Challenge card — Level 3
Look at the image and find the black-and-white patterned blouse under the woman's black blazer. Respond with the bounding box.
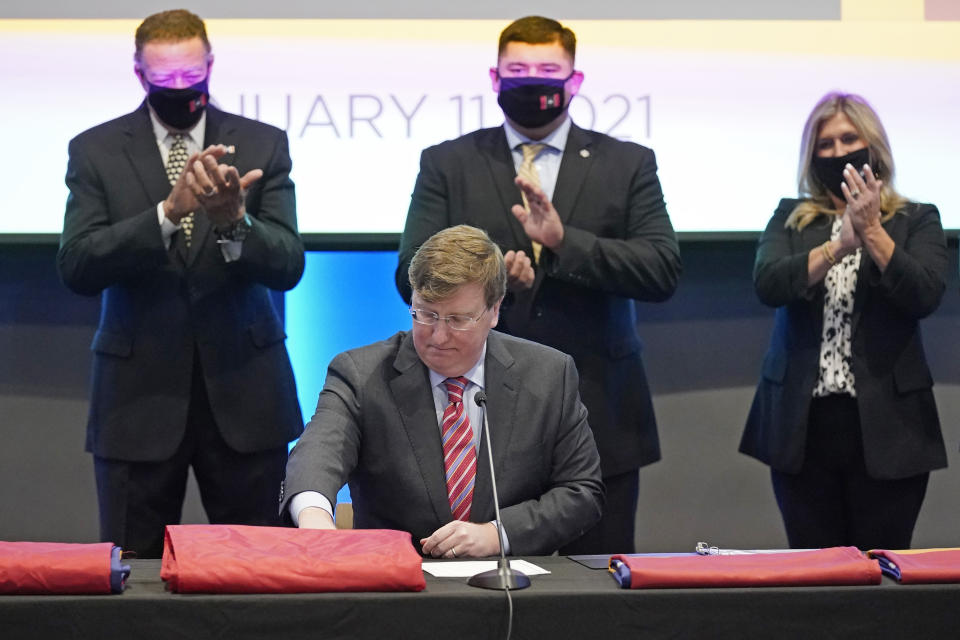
[813,216,861,398]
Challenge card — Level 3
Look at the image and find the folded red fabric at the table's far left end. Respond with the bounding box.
[0,542,113,594]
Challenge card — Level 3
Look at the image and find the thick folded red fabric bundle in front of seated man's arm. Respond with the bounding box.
[160,525,427,593]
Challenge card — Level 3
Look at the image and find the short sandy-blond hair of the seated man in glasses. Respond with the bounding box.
[407,224,507,308]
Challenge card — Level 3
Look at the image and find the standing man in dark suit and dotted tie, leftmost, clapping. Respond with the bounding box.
[57,10,303,557]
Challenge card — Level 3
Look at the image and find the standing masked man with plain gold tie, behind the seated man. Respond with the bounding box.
[396,16,680,554]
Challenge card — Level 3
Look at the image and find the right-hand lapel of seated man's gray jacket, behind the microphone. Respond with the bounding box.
[470,331,520,521]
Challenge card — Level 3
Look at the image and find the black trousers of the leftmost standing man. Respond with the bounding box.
[94,358,287,558]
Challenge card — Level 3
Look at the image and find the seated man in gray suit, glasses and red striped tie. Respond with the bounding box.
[280,225,603,558]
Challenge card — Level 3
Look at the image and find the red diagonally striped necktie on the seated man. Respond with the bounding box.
[440,377,477,521]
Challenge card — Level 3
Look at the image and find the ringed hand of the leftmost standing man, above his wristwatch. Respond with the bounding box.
[184,145,263,229]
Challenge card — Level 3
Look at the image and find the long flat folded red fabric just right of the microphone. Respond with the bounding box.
[613,547,880,589]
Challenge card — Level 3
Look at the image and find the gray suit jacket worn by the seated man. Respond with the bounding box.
[280,331,603,555]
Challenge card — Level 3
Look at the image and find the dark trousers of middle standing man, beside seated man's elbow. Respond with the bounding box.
[560,469,640,556]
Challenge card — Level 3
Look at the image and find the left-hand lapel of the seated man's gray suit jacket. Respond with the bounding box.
[390,333,453,522]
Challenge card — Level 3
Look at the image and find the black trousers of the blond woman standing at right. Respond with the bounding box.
[771,395,930,550]
